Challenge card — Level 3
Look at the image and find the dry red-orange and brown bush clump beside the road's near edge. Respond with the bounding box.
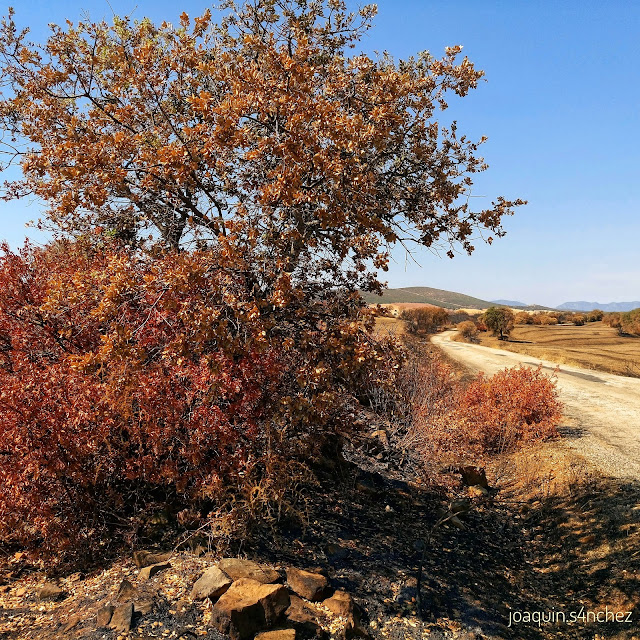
[396,348,562,473]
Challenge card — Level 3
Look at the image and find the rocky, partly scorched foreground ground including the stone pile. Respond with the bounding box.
[0,429,640,640]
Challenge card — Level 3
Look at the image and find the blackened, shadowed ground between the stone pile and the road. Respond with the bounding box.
[250,440,640,640]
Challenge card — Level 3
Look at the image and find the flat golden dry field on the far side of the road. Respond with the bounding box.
[480,322,640,377]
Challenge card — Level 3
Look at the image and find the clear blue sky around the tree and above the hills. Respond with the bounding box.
[0,0,640,305]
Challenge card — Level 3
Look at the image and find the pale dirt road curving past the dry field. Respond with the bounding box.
[432,331,640,480]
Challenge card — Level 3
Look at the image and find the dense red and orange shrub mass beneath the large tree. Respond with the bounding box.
[0,243,381,551]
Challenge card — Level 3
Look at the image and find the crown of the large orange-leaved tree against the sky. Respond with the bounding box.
[0,0,521,290]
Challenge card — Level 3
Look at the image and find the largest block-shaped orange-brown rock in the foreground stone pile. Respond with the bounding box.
[211,578,290,640]
